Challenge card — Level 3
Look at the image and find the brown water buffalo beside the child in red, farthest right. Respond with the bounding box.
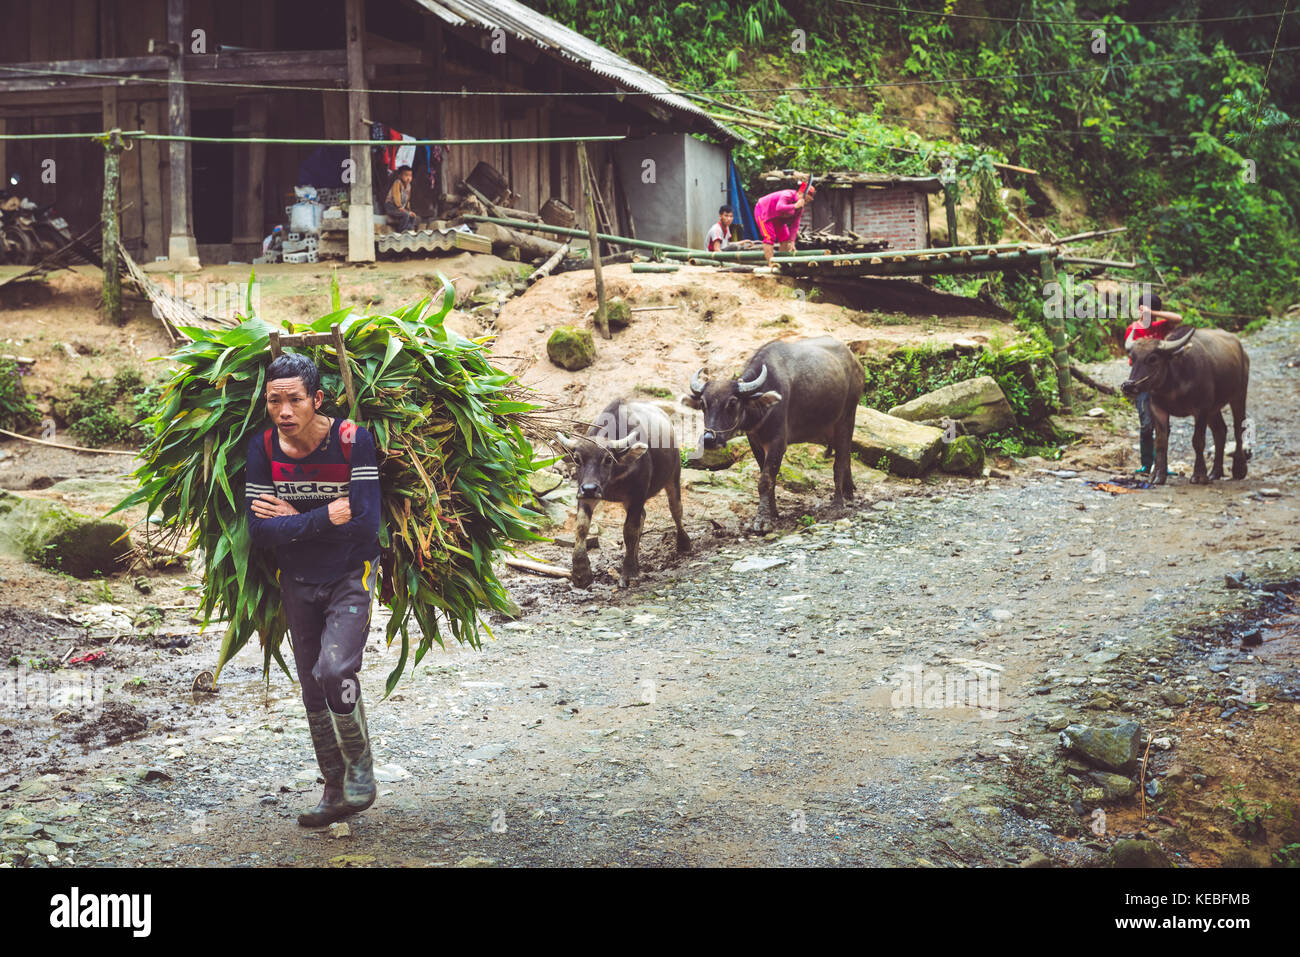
[1122,329,1251,485]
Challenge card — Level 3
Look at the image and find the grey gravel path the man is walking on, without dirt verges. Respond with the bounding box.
[0,322,1300,866]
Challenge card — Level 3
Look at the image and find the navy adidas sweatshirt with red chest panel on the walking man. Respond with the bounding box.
[244,419,380,584]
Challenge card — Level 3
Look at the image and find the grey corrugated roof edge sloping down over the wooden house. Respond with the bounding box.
[415,0,745,140]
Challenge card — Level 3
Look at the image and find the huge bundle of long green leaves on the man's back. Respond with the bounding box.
[114,280,545,693]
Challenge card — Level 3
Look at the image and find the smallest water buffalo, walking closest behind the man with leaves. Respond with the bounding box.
[559,399,690,588]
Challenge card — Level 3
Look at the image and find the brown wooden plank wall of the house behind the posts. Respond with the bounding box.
[0,0,691,250]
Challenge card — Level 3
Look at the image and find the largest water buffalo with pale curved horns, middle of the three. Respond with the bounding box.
[681,335,866,532]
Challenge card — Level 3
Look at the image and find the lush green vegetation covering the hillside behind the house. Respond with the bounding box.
[536,0,1300,358]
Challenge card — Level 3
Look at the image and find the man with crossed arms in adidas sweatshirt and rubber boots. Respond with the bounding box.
[244,352,380,827]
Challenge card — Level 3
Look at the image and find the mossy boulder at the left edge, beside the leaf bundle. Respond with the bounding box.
[0,492,131,579]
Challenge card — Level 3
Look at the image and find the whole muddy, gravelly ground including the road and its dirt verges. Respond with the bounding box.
[0,286,1300,866]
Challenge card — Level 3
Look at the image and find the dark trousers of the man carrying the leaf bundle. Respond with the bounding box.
[280,555,380,714]
